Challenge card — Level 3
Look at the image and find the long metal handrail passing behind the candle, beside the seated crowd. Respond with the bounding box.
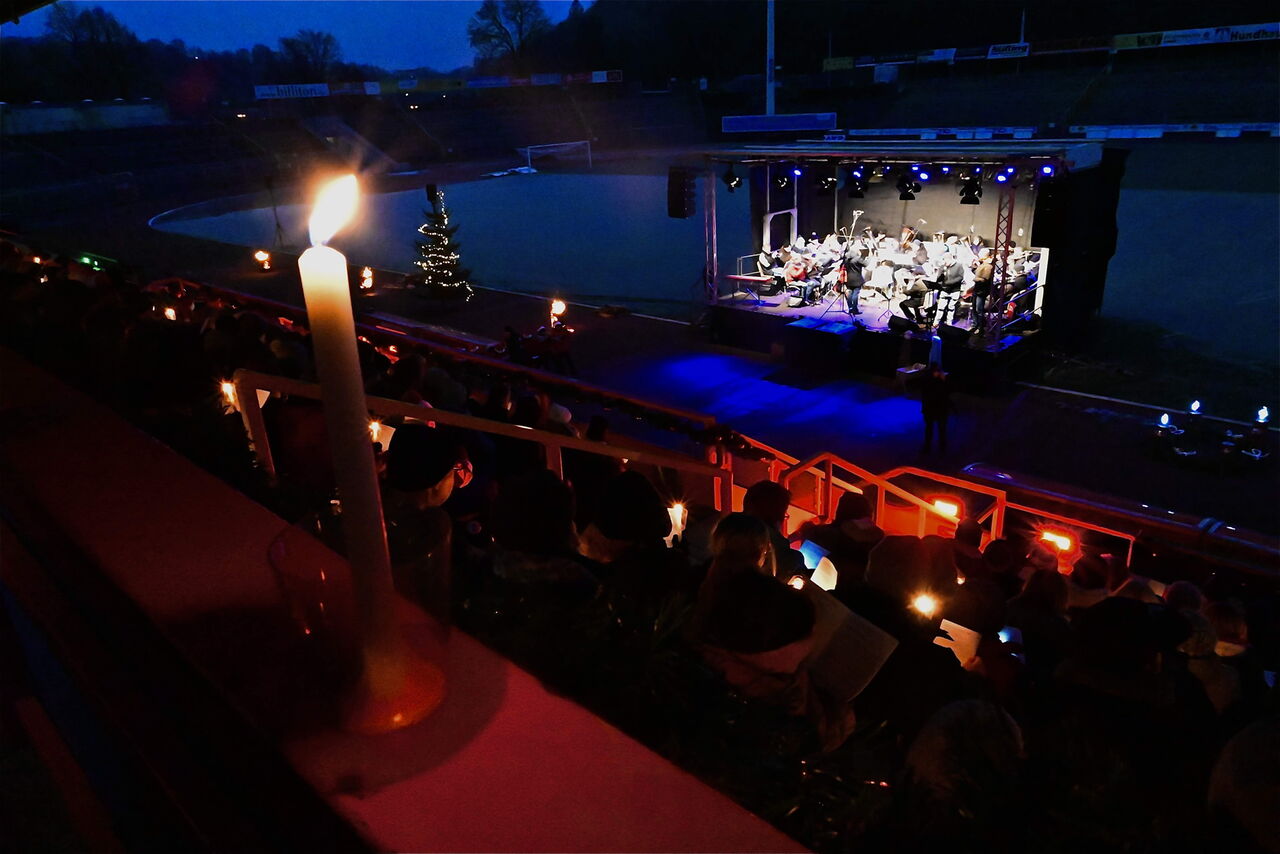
[232,369,733,510]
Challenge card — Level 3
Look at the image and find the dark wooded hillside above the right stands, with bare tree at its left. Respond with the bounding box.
[471,0,1275,83]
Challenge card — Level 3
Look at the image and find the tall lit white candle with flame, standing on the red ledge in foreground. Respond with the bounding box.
[298,175,444,732]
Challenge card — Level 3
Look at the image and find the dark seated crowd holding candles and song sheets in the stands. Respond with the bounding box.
[0,242,1280,851]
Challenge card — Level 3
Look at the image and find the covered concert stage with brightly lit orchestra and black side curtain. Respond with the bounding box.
[686,140,1123,388]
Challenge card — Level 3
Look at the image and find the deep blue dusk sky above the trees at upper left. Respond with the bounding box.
[0,0,590,70]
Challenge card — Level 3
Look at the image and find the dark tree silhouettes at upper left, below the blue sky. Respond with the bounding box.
[0,3,387,110]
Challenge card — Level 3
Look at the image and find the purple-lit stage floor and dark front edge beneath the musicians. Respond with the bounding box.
[710,288,1039,392]
